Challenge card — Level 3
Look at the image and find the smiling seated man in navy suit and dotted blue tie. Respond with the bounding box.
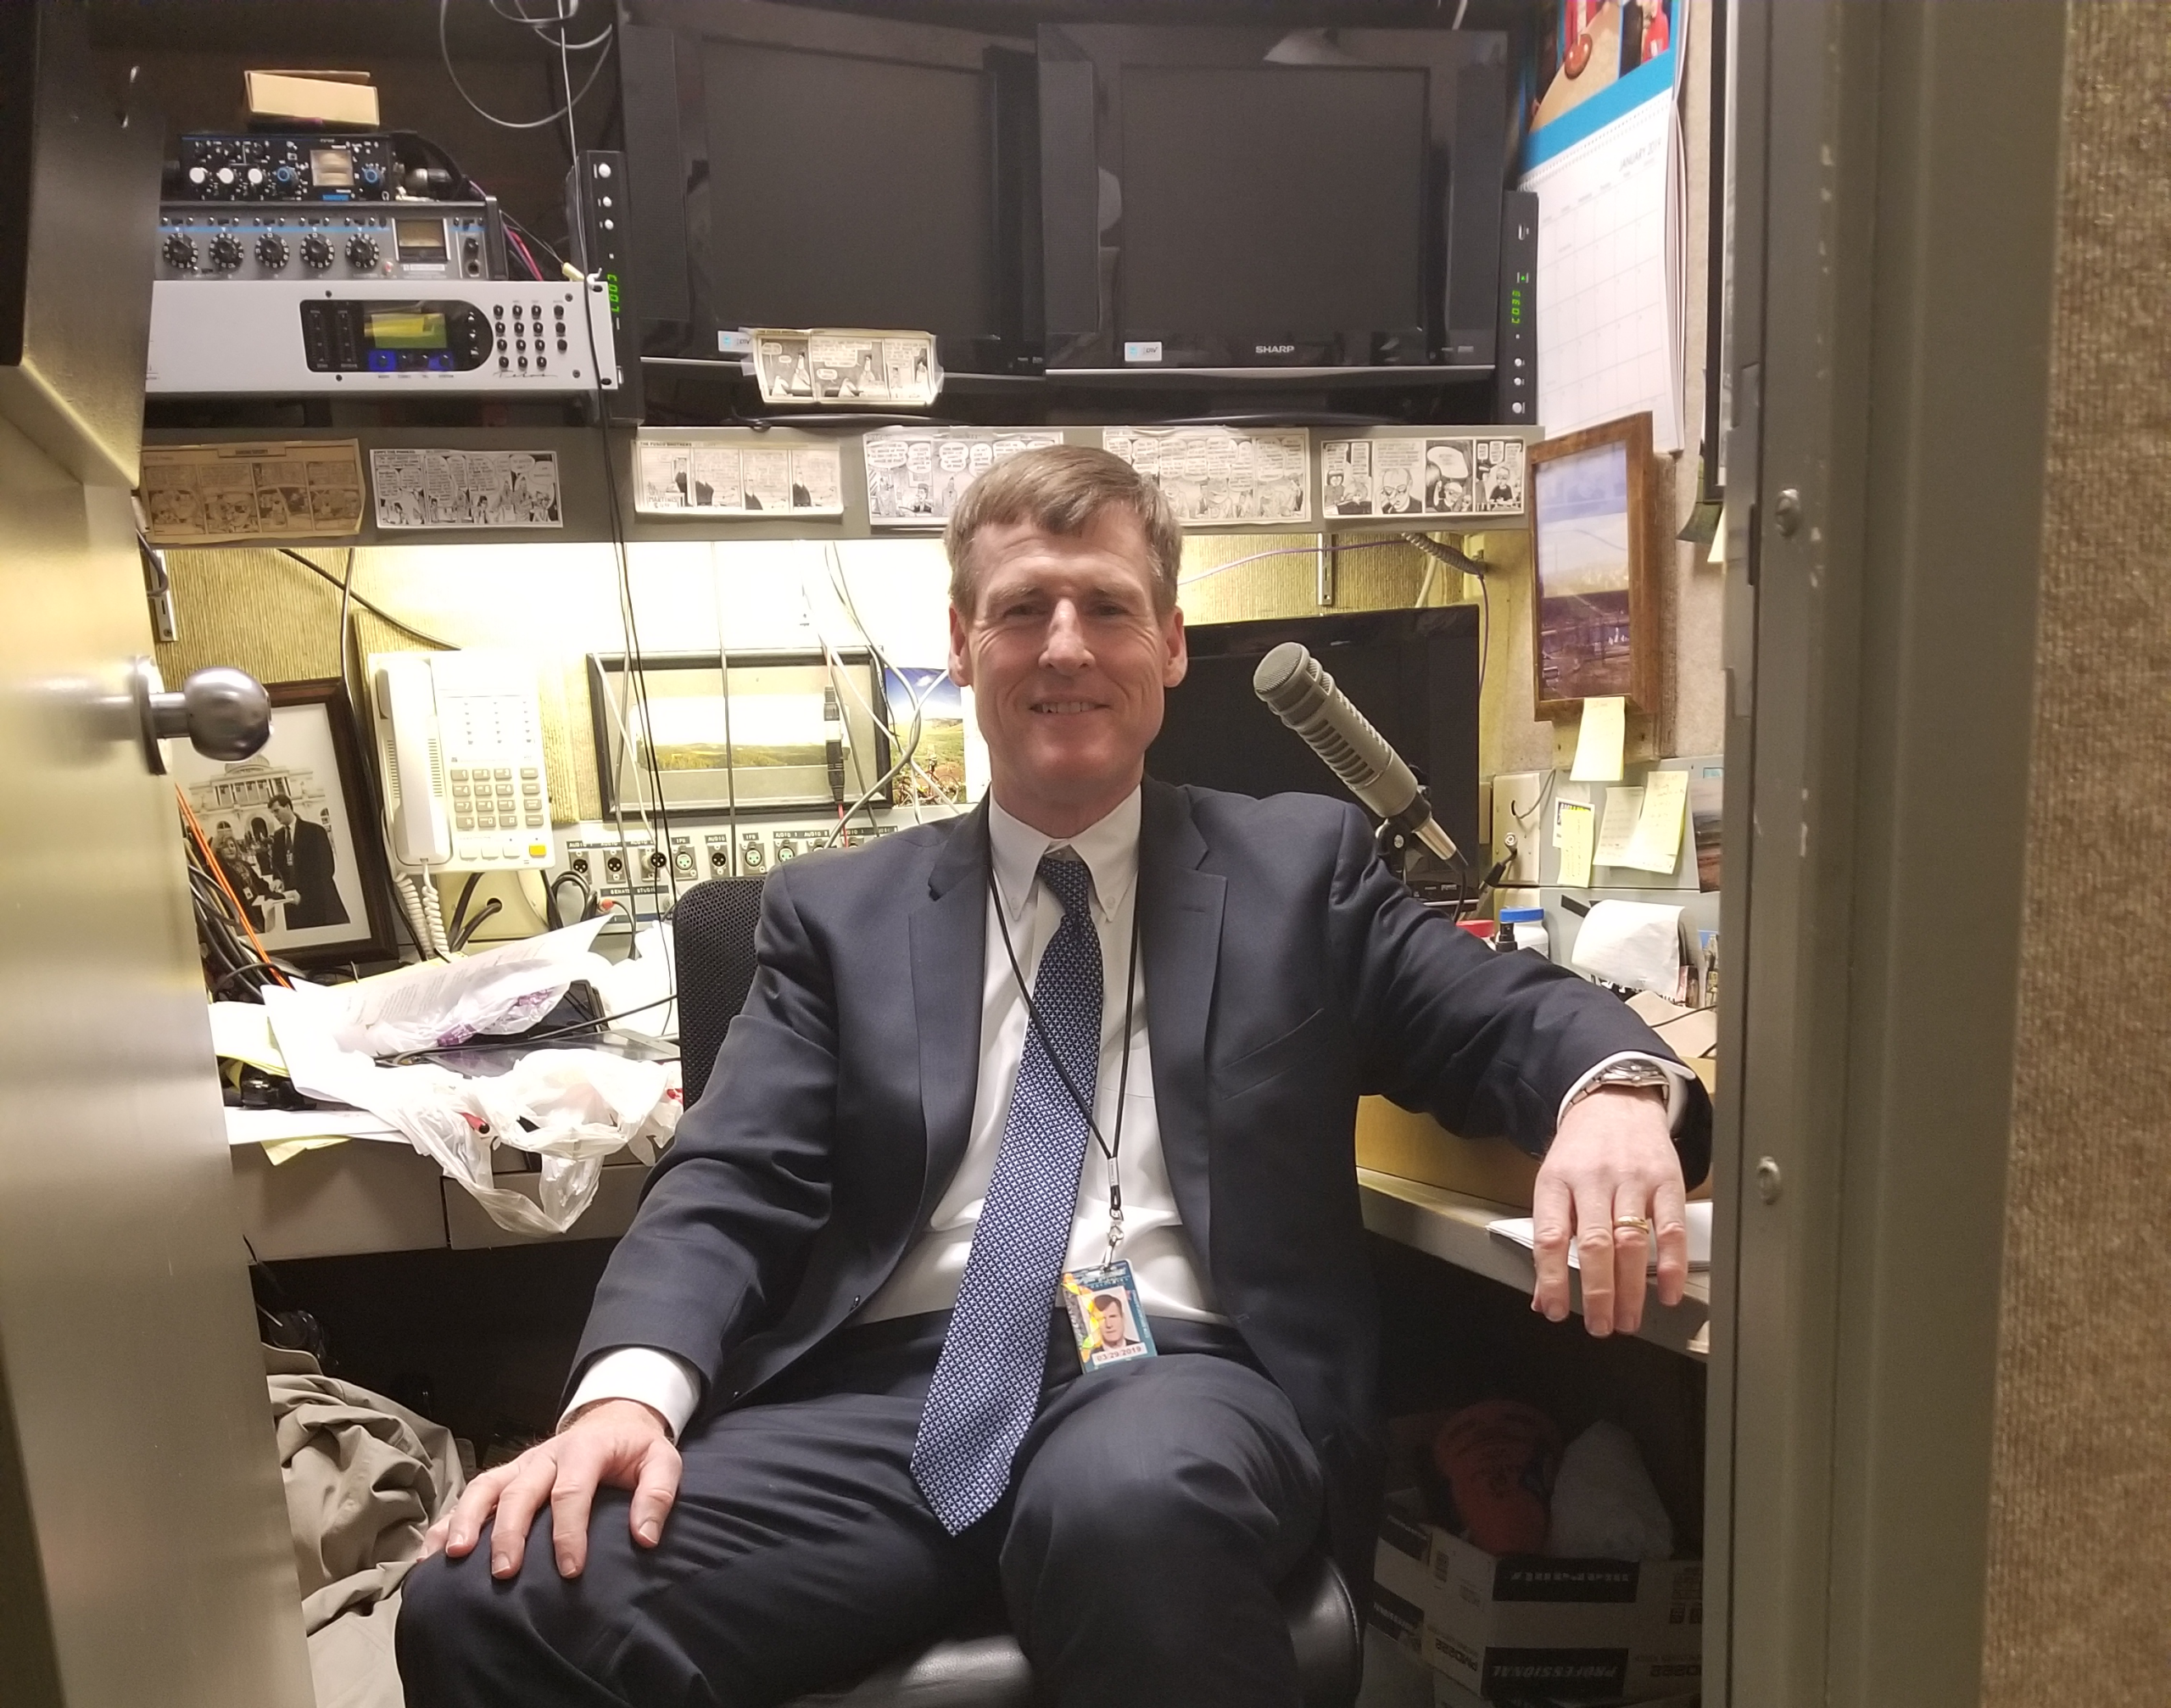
[397,447,1709,1708]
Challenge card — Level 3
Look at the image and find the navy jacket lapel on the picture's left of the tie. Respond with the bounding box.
[912,805,988,1228]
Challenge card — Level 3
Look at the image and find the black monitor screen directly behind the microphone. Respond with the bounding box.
[1147,606,1481,863]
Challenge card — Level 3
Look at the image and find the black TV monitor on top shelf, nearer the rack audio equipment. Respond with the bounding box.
[619,0,1040,373]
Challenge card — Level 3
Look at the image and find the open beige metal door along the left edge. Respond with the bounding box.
[0,7,310,1708]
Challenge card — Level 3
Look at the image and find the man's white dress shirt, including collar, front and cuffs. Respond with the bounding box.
[560,790,1689,1437]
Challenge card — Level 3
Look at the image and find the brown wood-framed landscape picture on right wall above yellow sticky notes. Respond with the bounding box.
[1531,412,1660,718]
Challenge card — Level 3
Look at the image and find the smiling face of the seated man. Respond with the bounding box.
[951,510,1186,835]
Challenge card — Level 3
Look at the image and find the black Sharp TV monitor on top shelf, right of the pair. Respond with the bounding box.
[1040,24,1509,380]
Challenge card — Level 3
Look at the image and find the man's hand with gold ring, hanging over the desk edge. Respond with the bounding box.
[1531,1086,1689,1335]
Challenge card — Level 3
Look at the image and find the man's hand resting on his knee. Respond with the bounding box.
[421,1400,679,1577]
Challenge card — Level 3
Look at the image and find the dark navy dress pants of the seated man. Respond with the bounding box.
[397,1313,1320,1708]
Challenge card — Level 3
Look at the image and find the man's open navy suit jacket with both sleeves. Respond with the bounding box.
[575,779,1711,1582]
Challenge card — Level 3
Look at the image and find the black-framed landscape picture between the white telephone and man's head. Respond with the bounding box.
[589,651,895,816]
